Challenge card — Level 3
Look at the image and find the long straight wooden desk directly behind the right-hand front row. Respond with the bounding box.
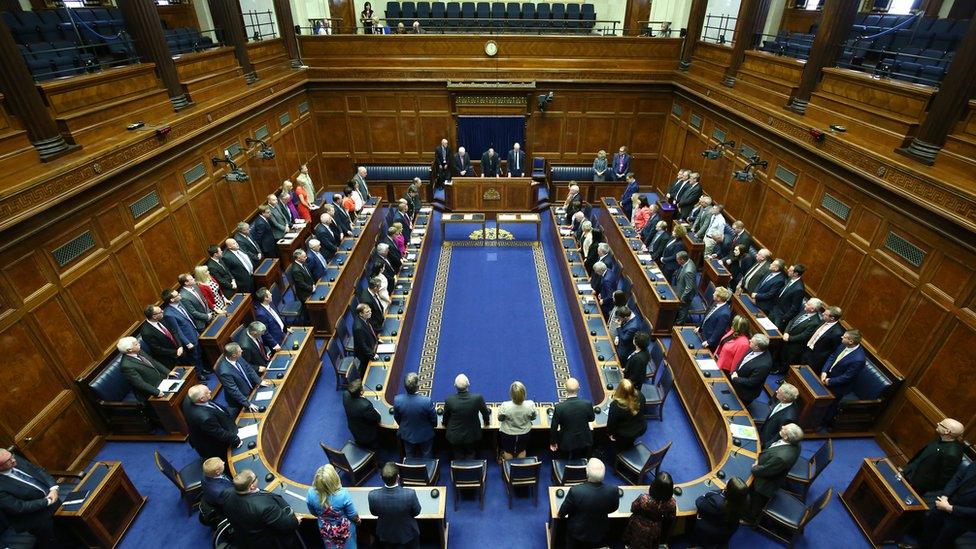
[599,198,681,337]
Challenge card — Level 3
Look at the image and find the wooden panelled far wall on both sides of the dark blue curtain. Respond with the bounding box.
[309,83,671,185]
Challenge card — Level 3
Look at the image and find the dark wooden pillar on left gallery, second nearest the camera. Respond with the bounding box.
[119,0,193,110]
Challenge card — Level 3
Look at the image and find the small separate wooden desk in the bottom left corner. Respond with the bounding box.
[54,461,146,547]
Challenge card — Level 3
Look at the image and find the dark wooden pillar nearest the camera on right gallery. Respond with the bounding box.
[897,19,976,165]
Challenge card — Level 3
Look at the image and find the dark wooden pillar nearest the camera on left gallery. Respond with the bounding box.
[0,16,78,162]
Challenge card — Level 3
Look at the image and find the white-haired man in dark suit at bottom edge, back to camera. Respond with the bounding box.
[559,458,620,549]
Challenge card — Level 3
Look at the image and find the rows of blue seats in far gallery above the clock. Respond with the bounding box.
[386,2,596,29]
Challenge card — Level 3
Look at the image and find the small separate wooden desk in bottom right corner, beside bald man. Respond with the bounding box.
[840,458,928,547]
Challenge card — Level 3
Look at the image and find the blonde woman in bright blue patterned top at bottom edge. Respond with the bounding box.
[305,464,360,549]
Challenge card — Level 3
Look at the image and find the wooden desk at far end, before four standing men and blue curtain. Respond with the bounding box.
[444,177,535,213]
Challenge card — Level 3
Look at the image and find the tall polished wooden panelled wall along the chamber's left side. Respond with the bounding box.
[0,91,318,469]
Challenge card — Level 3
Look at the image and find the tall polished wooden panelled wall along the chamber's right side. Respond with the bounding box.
[655,95,976,456]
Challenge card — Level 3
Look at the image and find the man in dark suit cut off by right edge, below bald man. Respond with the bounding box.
[920,461,976,549]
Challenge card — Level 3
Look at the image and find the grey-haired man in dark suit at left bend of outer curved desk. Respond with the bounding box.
[182,385,243,459]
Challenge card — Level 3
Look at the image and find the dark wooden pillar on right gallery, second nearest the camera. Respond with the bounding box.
[786,0,857,114]
